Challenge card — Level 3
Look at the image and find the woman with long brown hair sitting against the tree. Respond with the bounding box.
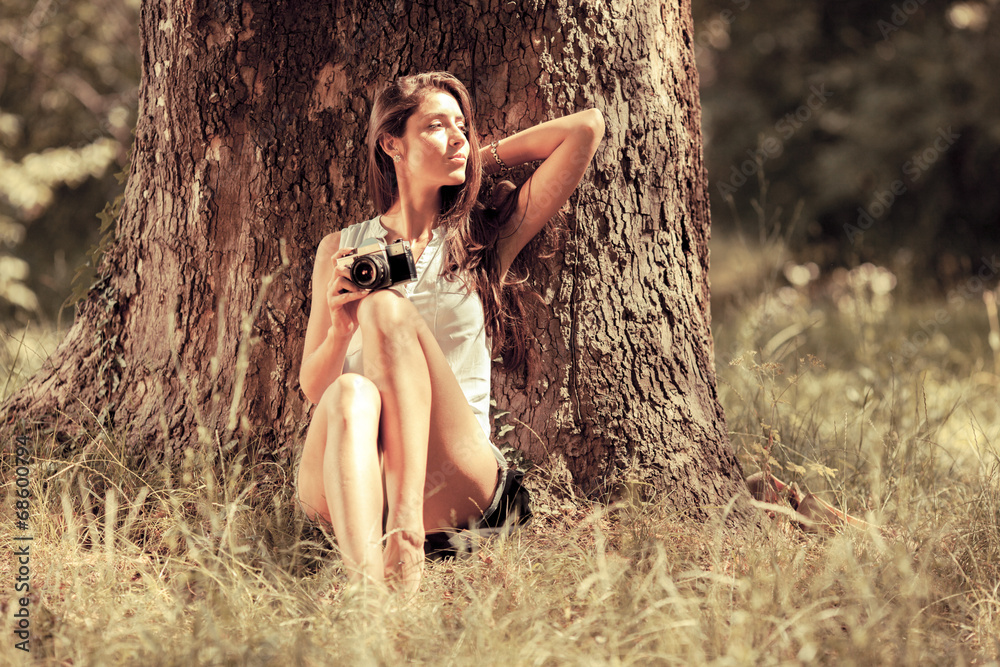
[298,72,604,592]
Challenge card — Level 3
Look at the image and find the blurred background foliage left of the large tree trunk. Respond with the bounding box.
[0,0,140,326]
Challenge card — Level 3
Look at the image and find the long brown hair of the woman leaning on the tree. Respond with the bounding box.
[368,72,561,381]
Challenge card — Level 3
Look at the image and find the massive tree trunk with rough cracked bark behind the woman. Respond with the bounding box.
[6,0,742,509]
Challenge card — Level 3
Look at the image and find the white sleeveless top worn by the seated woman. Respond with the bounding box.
[340,216,503,454]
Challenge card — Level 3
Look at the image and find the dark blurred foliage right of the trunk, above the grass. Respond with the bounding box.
[694,0,1000,287]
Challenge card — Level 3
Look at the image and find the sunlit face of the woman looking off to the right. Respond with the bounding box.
[390,89,469,186]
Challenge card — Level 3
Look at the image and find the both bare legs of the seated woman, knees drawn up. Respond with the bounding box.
[298,291,497,591]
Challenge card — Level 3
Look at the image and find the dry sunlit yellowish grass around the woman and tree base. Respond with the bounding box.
[0,238,1000,665]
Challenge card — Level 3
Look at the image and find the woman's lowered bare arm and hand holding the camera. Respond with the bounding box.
[299,232,368,403]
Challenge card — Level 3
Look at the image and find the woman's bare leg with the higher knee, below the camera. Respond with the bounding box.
[358,290,497,591]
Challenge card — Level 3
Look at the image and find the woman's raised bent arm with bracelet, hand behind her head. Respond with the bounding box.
[480,109,604,275]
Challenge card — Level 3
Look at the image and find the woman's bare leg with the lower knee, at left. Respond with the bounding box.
[299,373,383,584]
